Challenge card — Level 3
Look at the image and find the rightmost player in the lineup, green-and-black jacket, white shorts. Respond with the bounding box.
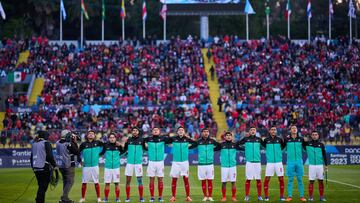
[306,131,327,202]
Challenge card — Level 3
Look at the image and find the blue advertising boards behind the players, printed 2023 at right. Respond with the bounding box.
[0,145,360,168]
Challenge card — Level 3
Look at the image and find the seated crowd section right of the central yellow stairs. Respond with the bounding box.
[209,37,360,144]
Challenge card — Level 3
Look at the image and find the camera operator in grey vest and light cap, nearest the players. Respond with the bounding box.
[56,130,80,203]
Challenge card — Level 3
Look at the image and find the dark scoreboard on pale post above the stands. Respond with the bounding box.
[167,0,245,39]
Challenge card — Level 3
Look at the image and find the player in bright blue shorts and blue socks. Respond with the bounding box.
[284,125,306,202]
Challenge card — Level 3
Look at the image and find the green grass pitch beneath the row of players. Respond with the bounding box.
[0,166,360,203]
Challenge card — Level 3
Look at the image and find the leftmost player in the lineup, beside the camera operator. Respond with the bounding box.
[80,130,103,202]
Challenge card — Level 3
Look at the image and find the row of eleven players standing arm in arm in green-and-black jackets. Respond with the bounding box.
[75,126,327,202]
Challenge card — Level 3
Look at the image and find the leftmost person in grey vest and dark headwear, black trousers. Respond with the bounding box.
[30,131,56,203]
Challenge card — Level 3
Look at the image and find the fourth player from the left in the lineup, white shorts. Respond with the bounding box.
[144,127,170,202]
